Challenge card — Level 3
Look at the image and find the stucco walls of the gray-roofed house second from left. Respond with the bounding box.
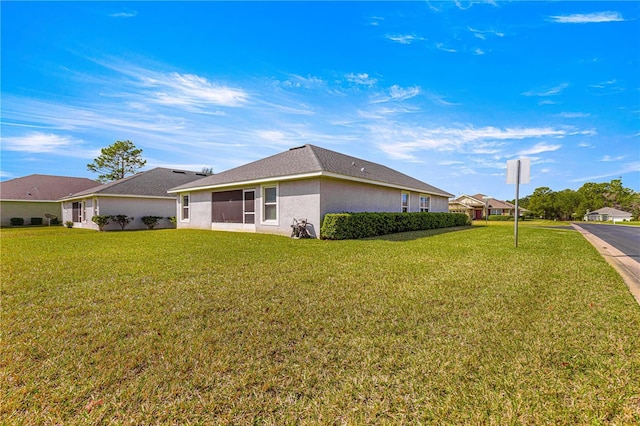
[62,197,176,231]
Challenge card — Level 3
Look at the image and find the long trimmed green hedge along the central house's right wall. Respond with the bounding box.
[320,213,469,240]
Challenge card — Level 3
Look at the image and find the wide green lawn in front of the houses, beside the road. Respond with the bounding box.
[0,222,640,424]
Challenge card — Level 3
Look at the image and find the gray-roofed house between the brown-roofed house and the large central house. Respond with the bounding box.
[60,167,208,230]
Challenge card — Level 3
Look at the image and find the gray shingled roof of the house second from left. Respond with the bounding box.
[60,167,208,199]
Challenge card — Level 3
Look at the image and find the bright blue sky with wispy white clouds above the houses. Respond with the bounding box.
[0,1,640,199]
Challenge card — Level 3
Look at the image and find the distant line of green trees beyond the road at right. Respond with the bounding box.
[510,179,640,220]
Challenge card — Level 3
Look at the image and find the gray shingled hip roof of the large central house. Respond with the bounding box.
[171,145,453,197]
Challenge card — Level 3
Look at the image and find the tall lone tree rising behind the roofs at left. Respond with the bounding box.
[87,140,147,183]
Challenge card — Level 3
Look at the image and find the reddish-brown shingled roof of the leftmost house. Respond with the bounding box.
[0,174,99,201]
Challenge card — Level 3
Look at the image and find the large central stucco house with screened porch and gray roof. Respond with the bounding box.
[169,145,452,237]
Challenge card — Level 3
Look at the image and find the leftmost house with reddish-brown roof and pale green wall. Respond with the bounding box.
[0,174,99,226]
